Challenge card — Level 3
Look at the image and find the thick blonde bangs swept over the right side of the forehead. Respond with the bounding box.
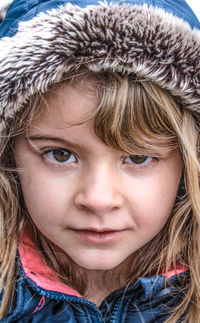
[94,72,182,154]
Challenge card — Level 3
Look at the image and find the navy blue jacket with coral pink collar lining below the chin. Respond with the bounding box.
[0,237,189,323]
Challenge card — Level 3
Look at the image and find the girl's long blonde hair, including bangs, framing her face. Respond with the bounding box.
[0,68,200,323]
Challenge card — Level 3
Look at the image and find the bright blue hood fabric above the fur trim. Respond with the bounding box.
[0,0,200,38]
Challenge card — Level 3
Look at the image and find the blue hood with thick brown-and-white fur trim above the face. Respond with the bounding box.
[0,0,200,129]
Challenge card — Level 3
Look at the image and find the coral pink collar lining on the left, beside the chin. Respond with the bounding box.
[18,235,81,297]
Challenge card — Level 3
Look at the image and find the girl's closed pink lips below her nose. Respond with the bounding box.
[73,228,126,244]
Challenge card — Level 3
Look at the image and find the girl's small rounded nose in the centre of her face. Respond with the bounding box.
[75,166,123,215]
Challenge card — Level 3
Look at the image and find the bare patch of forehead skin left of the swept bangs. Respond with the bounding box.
[32,79,99,127]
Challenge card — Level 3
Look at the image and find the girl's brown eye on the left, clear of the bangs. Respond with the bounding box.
[45,149,76,163]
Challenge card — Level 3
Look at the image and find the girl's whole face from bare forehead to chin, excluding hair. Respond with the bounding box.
[15,81,182,270]
